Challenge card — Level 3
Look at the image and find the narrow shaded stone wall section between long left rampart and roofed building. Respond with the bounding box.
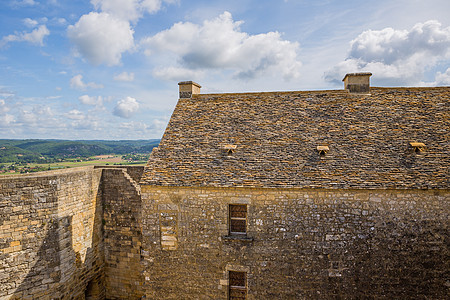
[102,167,143,299]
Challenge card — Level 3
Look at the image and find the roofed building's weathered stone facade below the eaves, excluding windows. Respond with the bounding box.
[141,186,450,299]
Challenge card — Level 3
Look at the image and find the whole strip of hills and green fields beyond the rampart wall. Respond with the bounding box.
[0,139,159,175]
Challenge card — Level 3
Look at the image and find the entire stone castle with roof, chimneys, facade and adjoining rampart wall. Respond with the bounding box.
[0,73,450,300]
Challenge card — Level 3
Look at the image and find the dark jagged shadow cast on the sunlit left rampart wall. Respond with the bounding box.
[8,172,105,300]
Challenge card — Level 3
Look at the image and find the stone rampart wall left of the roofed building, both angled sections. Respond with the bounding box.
[0,167,143,300]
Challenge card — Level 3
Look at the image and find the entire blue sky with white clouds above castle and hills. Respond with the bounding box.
[0,0,450,140]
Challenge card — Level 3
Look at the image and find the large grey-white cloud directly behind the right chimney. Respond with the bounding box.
[325,21,450,84]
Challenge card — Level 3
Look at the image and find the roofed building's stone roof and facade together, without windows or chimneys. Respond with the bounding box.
[141,83,450,299]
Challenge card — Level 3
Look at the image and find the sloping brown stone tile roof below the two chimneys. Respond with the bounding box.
[141,87,450,189]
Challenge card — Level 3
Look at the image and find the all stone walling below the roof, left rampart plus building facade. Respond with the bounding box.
[0,167,450,300]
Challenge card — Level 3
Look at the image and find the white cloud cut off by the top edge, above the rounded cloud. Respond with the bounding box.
[91,0,161,21]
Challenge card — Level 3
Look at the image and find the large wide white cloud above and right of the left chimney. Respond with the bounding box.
[141,12,301,79]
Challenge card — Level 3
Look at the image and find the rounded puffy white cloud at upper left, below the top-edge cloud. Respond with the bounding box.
[67,12,134,66]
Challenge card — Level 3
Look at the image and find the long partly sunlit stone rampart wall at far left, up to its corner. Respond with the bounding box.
[0,167,104,299]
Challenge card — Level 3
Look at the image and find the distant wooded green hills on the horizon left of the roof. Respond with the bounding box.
[0,139,160,163]
